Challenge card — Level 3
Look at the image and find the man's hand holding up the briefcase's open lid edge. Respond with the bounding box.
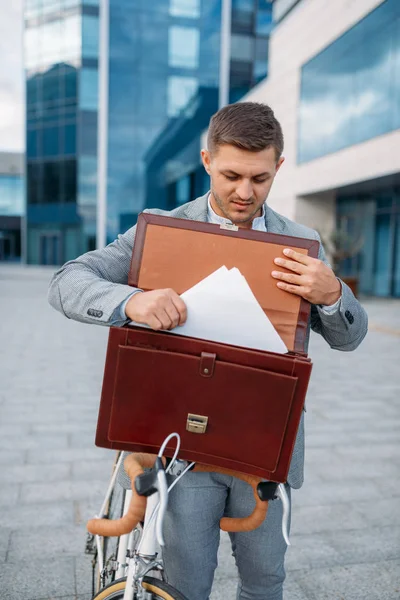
[272,248,342,306]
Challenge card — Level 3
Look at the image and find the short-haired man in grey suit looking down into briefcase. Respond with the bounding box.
[49,102,367,600]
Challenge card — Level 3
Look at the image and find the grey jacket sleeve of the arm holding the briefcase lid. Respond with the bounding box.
[311,234,368,351]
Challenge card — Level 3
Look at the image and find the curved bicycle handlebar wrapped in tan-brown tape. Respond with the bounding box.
[87,453,268,537]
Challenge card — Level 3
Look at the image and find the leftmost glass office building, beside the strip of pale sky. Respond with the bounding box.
[25,0,99,264]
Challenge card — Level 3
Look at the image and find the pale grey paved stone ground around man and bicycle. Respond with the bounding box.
[0,265,400,600]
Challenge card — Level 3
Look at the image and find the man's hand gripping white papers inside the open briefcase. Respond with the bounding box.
[125,289,187,330]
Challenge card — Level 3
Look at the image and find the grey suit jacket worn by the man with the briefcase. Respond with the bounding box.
[48,194,367,488]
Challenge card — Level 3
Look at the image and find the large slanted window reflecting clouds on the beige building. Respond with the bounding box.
[298,0,400,163]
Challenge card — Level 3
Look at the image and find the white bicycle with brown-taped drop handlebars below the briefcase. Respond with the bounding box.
[86,433,290,600]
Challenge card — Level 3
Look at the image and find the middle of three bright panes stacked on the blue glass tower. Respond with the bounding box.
[168,25,200,69]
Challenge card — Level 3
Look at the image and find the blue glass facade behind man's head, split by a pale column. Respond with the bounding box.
[104,0,271,241]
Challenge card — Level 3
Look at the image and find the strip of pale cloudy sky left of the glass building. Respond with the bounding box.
[0,0,25,152]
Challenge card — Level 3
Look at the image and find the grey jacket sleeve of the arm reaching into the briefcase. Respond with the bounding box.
[48,226,136,325]
